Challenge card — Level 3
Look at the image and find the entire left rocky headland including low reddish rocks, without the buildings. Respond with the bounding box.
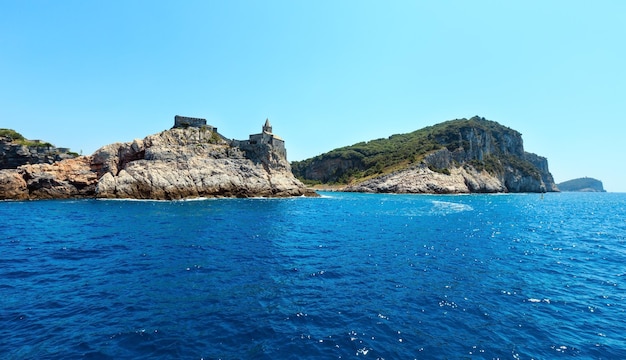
[0,127,316,199]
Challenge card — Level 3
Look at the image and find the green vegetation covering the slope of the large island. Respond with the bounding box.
[291,116,539,184]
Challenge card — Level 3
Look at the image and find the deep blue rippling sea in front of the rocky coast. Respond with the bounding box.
[0,192,626,359]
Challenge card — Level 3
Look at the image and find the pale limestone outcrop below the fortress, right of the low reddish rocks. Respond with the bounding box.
[94,128,314,199]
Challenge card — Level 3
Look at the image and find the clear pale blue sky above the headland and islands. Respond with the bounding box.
[0,0,626,192]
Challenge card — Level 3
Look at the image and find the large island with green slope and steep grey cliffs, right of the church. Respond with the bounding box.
[291,116,559,194]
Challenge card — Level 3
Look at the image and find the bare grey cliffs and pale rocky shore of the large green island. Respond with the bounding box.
[346,127,558,194]
